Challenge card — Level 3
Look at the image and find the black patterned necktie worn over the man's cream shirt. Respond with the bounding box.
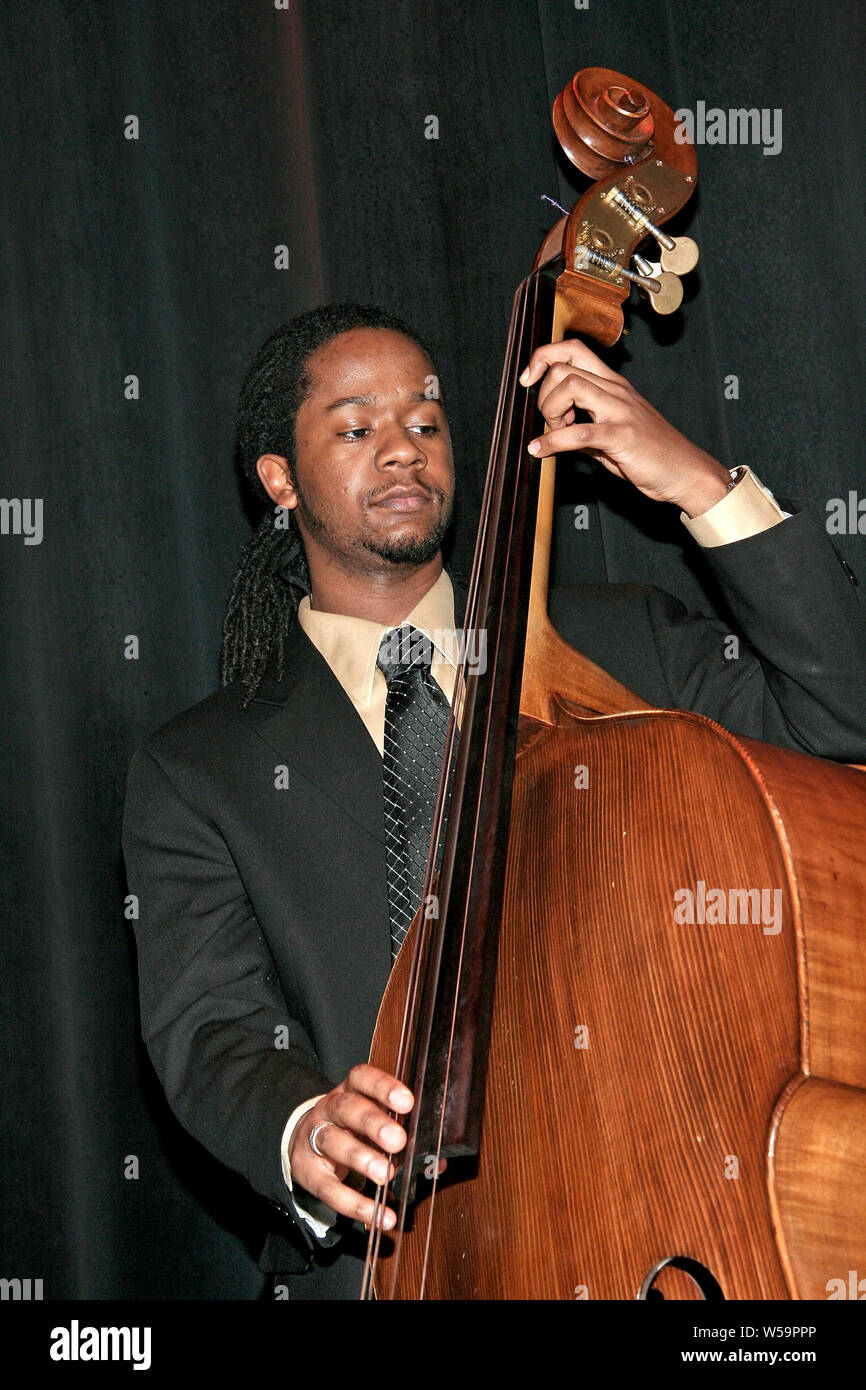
[377,626,453,959]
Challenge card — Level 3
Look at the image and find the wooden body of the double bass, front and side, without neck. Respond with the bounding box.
[371,700,866,1300]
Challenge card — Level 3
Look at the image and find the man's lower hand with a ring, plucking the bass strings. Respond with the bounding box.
[289,1062,414,1230]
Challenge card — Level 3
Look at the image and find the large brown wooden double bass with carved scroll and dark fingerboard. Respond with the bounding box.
[361,68,866,1300]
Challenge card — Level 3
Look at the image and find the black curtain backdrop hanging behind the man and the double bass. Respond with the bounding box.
[0,0,866,1300]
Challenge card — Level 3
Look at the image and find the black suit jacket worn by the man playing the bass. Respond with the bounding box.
[124,510,866,1284]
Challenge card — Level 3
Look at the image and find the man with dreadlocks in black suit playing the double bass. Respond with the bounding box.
[124,304,866,1297]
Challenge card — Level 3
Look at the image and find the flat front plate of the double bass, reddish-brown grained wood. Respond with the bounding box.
[374,710,799,1298]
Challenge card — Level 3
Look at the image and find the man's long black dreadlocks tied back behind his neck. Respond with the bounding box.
[220,303,444,706]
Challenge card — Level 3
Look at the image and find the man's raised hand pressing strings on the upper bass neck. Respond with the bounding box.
[520,338,731,517]
